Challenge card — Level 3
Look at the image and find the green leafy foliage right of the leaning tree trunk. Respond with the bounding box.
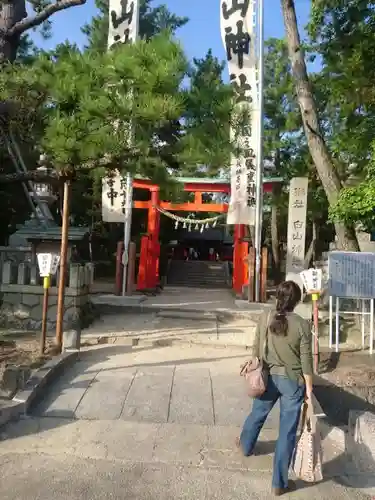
[309,0,375,230]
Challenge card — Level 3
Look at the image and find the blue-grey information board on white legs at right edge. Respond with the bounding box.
[328,251,375,299]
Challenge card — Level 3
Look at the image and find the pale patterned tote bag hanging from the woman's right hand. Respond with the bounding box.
[293,402,323,483]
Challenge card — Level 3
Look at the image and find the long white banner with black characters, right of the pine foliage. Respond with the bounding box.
[220,0,259,225]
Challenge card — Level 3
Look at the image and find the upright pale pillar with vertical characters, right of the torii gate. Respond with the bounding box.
[286,177,309,284]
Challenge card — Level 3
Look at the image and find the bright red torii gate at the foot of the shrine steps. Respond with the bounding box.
[133,177,281,293]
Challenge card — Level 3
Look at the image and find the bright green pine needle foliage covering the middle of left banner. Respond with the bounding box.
[1,36,187,173]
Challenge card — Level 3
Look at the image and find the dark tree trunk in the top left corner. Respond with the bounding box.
[0,0,27,64]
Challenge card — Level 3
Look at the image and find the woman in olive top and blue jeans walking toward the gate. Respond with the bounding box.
[239,281,313,496]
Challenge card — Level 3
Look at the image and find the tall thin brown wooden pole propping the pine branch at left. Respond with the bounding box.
[56,180,71,352]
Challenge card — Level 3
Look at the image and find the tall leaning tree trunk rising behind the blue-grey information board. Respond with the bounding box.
[281,0,359,251]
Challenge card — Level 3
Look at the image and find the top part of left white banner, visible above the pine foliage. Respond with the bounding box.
[108,0,139,49]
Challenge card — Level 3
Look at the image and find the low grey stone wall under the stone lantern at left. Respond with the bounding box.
[0,261,93,330]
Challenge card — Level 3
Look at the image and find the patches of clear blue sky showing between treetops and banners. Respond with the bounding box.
[34,0,310,60]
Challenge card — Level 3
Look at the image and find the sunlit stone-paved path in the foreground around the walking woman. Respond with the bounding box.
[0,344,368,500]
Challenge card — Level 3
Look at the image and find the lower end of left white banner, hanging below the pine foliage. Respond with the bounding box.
[102,173,132,223]
